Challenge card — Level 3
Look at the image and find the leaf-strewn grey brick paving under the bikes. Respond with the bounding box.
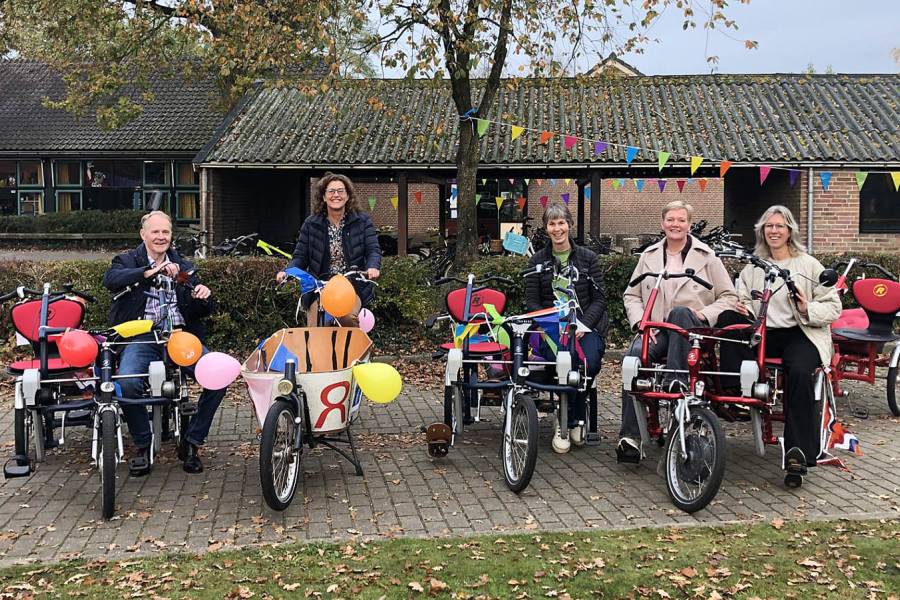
[0,368,900,565]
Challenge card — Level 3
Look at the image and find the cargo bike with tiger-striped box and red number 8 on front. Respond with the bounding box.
[241,268,402,511]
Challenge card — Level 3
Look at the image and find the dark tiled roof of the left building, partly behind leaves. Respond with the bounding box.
[0,60,225,155]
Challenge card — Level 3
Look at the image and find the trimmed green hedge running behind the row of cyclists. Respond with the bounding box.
[0,254,900,356]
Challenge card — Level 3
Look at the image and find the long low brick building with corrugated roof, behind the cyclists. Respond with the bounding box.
[195,75,900,251]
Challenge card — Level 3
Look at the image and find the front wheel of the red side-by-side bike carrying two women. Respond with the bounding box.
[666,407,725,513]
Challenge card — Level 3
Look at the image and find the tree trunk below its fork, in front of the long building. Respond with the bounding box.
[453,121,481,273]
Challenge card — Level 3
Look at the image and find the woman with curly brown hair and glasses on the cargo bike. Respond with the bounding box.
[276,173,381,327]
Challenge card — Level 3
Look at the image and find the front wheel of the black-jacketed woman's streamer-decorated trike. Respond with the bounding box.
[501,394,539,494]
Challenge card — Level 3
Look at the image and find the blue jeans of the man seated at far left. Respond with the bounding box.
[116,335,227,448]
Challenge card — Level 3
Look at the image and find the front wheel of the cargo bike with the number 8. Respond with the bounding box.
[259,400,300,510]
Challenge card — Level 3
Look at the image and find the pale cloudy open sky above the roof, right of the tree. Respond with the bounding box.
[622,0,900,75]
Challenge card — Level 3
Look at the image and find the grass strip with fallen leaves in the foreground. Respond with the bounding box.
[0,519,900,599]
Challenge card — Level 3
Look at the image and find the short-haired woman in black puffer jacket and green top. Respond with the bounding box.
[525,203,609,453]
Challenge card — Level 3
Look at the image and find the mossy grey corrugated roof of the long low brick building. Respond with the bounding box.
[195,75,900,167]
